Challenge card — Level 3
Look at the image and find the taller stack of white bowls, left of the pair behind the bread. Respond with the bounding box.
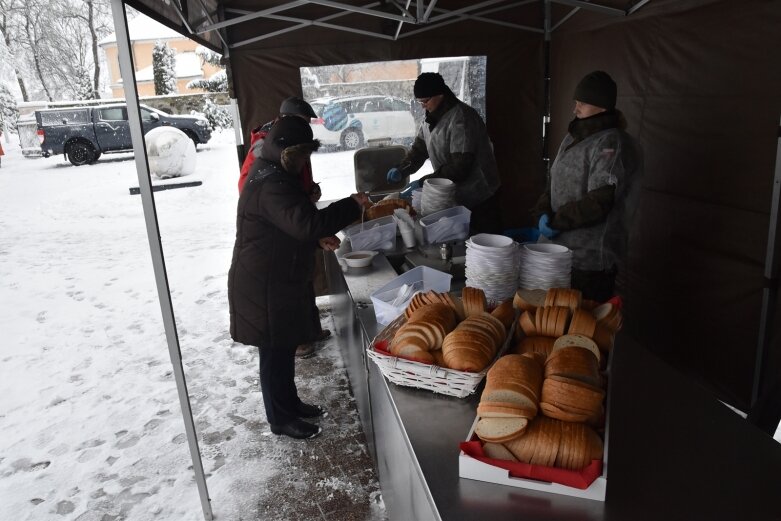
[464,233,520,304]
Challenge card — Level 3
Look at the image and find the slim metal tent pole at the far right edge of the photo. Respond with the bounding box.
[751,121,781,407]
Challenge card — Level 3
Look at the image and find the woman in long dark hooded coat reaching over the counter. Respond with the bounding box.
[228,118,367,438]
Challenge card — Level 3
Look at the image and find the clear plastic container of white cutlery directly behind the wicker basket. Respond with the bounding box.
[371,266,453,326]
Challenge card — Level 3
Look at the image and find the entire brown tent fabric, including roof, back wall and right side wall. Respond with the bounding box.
[126,0,781,409]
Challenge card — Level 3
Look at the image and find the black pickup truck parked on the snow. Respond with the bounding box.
[35,104,211,166]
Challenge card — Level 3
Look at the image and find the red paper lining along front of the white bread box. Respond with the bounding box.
[459,440,602,490]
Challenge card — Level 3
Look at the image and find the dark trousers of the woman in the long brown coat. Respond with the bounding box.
[258,346,301,425]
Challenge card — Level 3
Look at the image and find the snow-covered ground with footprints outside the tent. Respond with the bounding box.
[0,132,388,521]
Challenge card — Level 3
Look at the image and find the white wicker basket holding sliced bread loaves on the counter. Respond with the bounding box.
[366,313,516,398]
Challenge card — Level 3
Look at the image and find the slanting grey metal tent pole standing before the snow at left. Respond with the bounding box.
[111,0,214,521]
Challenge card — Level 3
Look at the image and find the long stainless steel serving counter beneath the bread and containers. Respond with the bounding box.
[327,250,781,521]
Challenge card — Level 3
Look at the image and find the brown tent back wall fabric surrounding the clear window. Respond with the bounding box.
[231,29,544,230]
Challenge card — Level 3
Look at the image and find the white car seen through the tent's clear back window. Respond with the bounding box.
[309,96,417,150]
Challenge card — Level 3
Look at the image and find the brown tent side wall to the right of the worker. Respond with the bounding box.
[551,0,781,408]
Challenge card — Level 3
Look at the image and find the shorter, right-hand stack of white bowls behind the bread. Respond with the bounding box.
[518,242,572,289]
